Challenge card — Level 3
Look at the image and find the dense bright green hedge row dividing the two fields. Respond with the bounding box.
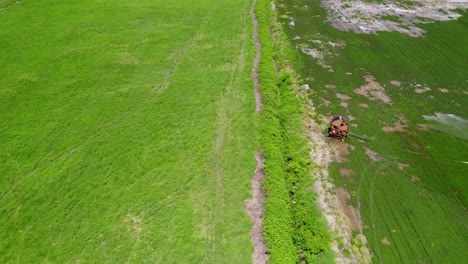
[255,0,332,264]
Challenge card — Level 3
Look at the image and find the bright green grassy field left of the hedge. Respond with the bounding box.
[0,0,258,263]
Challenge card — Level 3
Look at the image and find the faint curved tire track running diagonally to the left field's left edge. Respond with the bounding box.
[0,16,209,201]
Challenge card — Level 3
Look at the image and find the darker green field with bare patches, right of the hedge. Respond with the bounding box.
[276,0,468,263]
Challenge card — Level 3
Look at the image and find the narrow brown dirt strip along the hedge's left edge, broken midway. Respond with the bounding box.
[245,0,268,264]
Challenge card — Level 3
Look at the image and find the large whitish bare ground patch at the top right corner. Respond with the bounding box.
[321,0,468,37]
